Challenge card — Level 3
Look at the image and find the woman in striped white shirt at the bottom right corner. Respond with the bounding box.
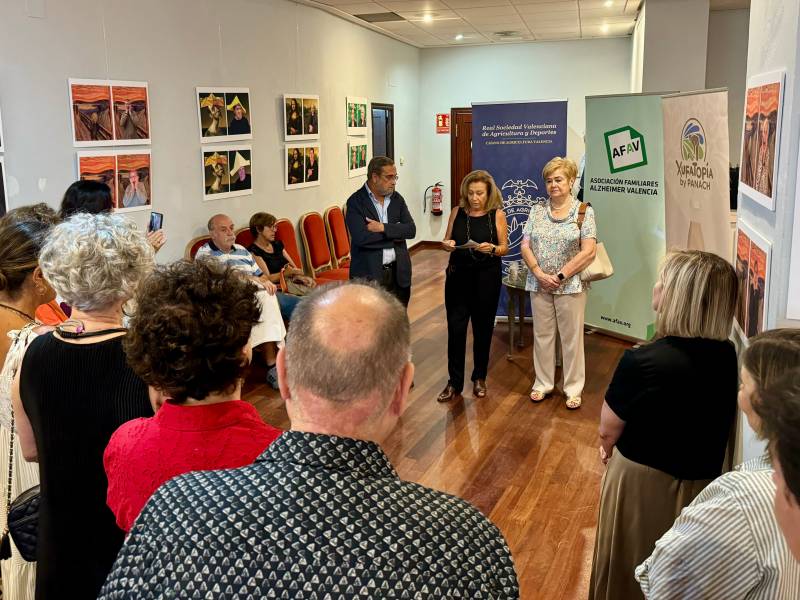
[636,329,800,599]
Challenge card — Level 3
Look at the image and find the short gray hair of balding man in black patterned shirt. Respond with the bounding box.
[285,281,411,403]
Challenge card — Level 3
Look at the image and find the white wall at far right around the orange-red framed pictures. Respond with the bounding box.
[739,0,800,458]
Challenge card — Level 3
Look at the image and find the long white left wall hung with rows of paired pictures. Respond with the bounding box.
[0,0,419,260]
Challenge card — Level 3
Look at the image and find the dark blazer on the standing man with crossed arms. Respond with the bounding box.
[345,186,417,287]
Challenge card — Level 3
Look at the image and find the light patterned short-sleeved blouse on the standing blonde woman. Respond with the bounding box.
[522,199,597,294]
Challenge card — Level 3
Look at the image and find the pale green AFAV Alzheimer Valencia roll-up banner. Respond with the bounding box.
[584,94,665,340]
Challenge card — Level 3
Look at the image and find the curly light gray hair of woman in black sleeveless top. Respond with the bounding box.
[39,213,153,311]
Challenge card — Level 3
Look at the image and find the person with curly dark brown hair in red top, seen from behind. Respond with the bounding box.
[103,260,281,531]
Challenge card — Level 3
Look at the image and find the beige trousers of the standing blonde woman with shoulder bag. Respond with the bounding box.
[531,292,586,398]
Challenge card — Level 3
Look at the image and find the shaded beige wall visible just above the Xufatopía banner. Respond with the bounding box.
[706,9,750,166]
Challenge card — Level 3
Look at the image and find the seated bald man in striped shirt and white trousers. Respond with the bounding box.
[195,214,286,390]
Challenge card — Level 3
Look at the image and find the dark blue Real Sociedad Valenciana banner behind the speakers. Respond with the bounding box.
[472,100,567,316]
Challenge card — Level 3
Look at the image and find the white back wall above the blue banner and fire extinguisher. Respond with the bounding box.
[413,38,631,240]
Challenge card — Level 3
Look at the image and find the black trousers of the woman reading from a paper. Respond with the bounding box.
[444,260,501,392]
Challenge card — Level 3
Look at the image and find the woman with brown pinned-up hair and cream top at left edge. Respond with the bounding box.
[0,204,58,600]
